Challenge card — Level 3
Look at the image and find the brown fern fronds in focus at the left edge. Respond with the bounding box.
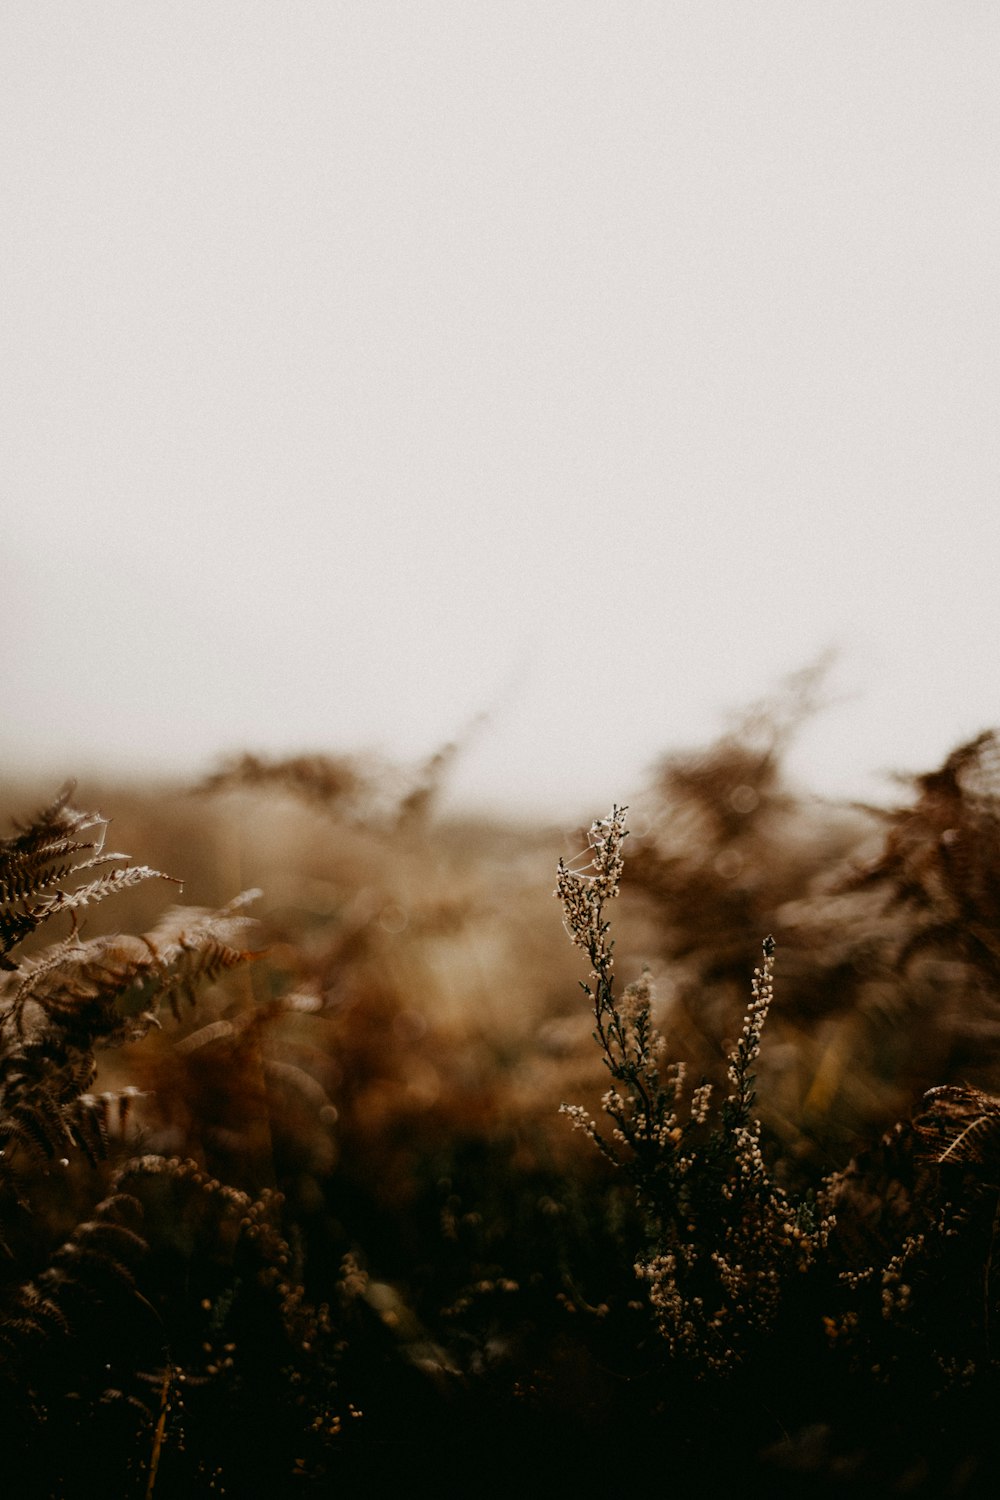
[0,785,258,1199]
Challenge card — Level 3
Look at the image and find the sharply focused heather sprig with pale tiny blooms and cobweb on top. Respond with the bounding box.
[556,807,831,1376]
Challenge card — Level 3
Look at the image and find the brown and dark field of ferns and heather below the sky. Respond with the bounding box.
[0,692,1000,1500]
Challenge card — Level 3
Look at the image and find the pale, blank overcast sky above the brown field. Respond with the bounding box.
[0,0,1000,815]
